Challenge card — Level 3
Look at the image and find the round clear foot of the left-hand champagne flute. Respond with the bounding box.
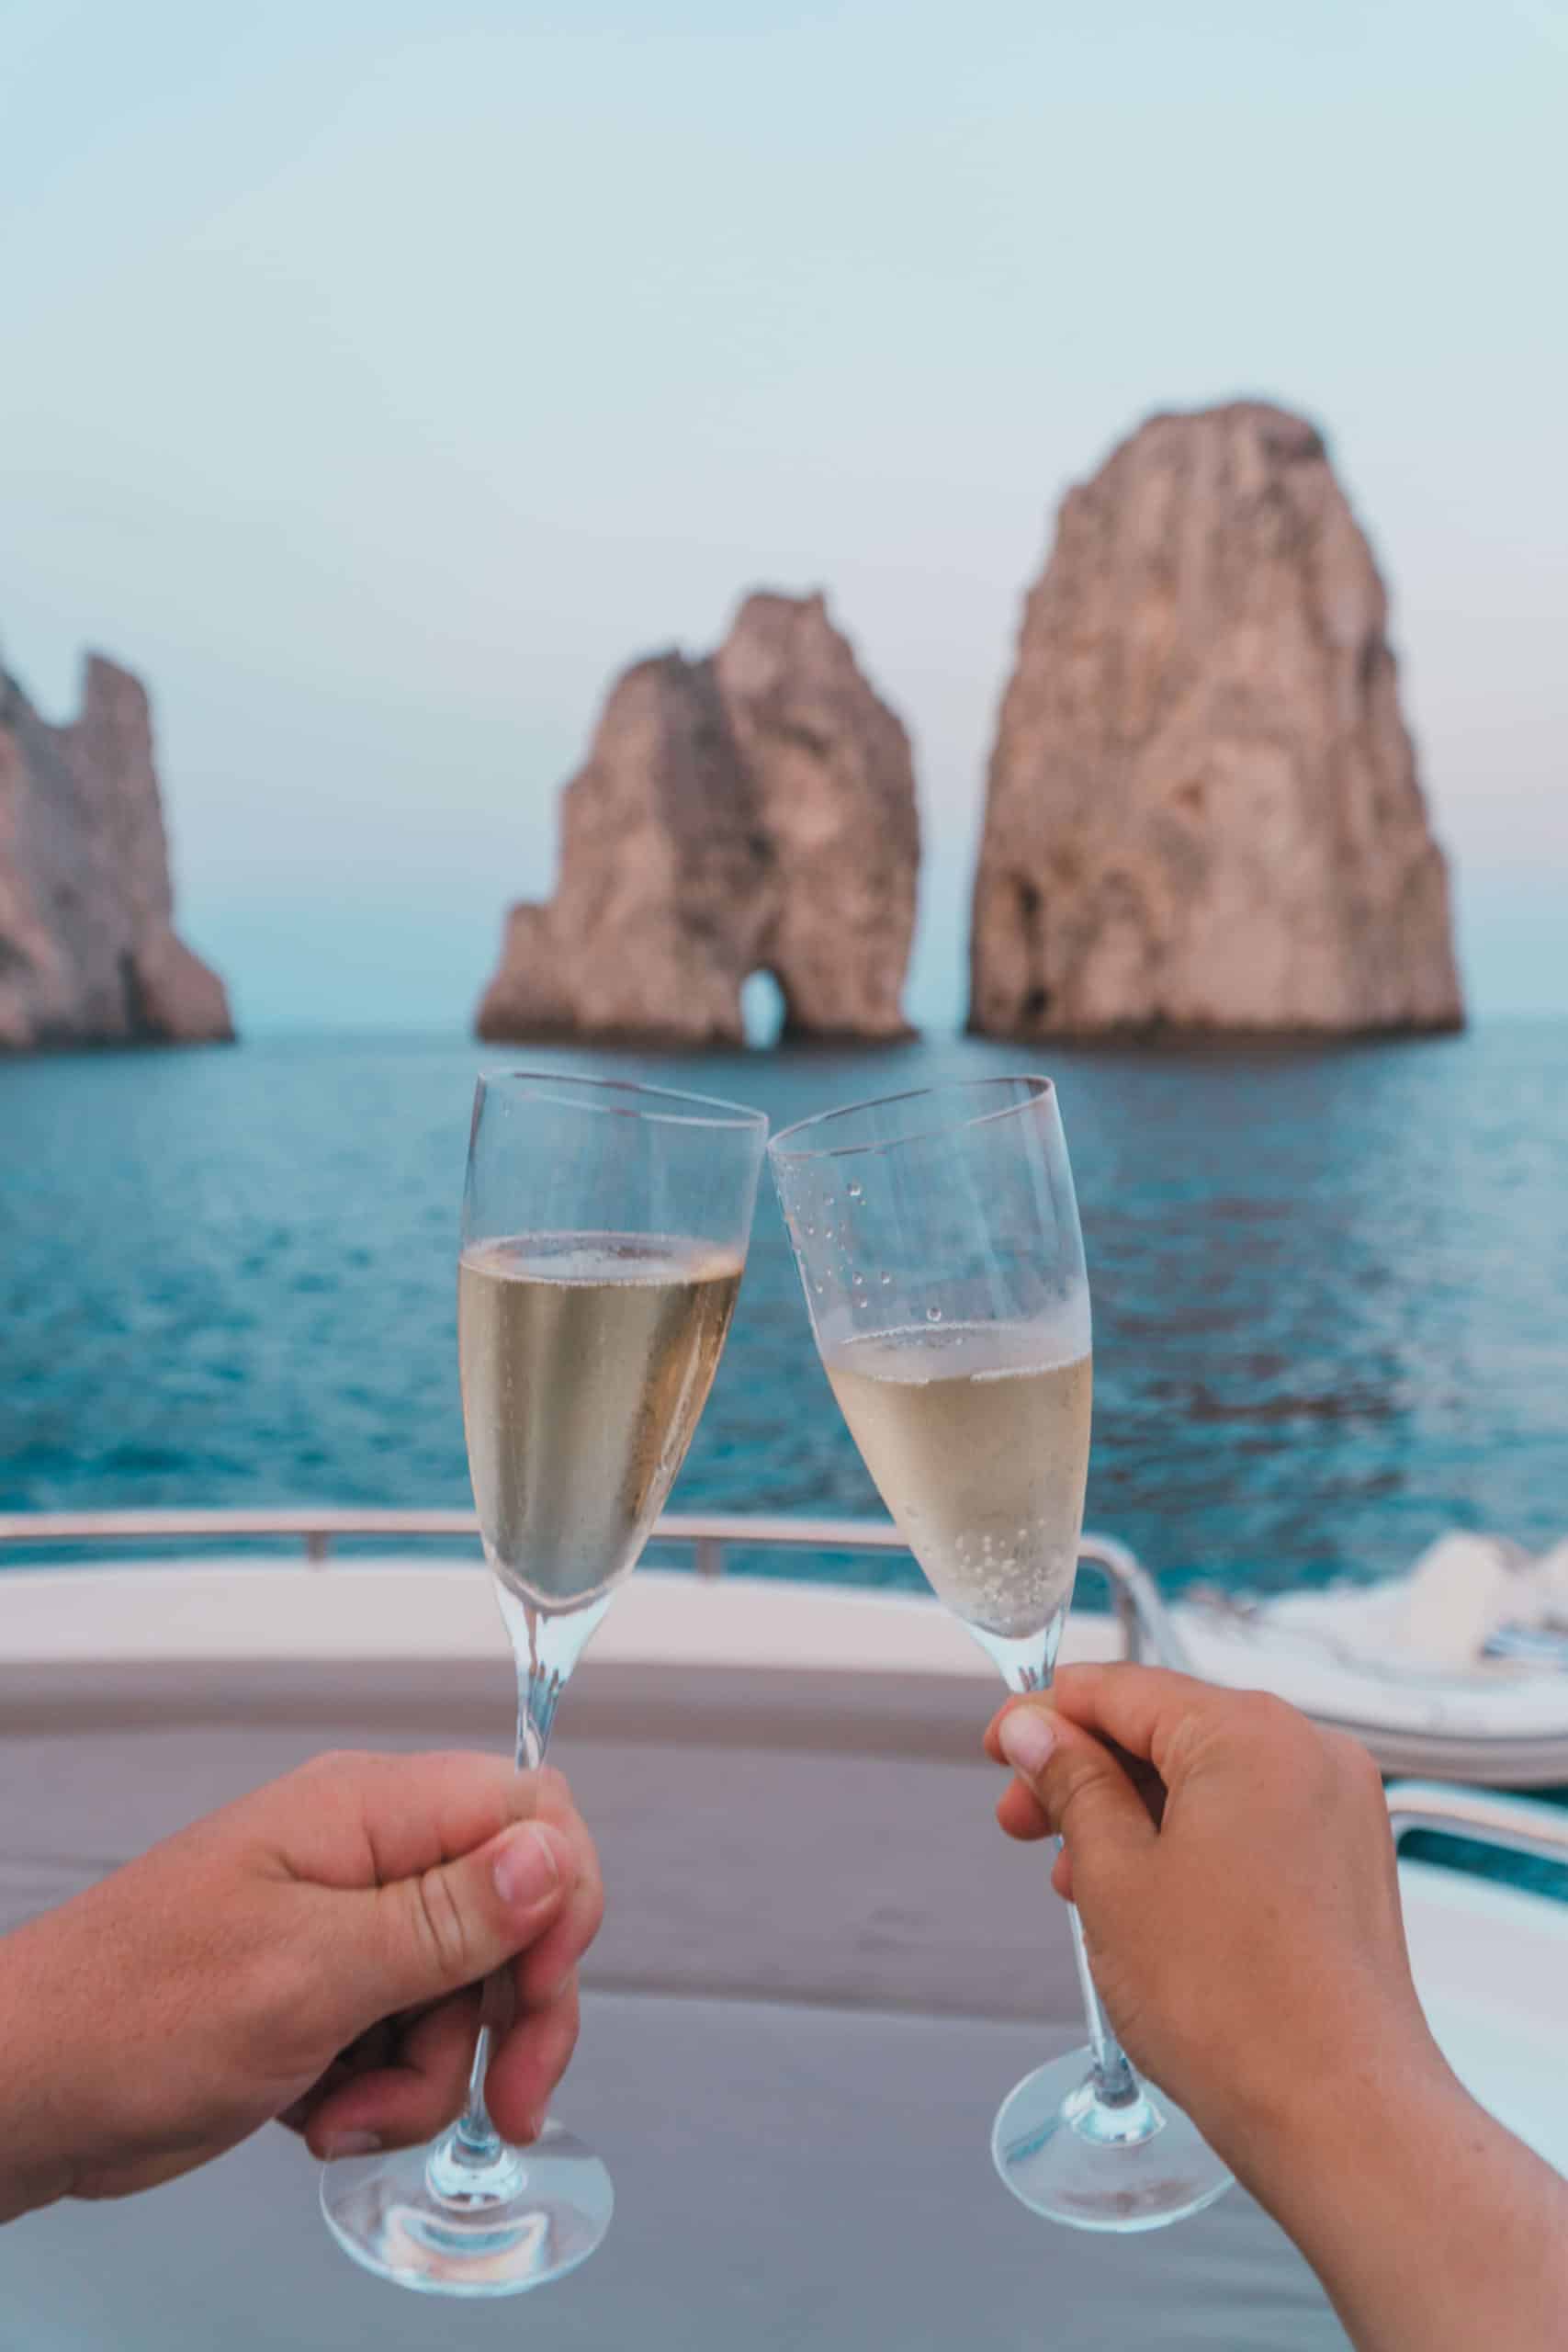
[322,2124,616,2296]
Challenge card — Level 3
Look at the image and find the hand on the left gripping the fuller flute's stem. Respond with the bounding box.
[0,1755,604,2221]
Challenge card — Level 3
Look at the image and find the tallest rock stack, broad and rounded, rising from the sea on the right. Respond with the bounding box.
[968,402,1464,1037]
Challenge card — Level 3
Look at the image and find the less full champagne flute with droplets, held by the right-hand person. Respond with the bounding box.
[769,1077,1229,2230]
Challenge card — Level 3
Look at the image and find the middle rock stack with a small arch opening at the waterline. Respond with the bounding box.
[478,595,919,1046]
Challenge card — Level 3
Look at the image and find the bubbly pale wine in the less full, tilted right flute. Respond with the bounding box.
[825,1317,1093,1639]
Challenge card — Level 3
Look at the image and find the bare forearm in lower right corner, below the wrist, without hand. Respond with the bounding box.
[1248,2067,1568,2352]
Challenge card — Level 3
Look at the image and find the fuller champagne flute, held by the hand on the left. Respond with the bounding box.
[322,1070,766,2296]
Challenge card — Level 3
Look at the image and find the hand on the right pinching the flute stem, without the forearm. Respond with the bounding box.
[987,1665,1453,2192]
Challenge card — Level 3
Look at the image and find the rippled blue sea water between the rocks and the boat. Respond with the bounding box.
[0,1023,1568,1590]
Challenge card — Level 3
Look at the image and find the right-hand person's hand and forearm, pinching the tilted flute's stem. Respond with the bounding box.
[985,1665,1568,2352]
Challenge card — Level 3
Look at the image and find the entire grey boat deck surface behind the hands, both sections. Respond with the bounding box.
[0,1677,1345,2352]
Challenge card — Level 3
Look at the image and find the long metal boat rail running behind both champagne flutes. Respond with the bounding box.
[0,1505,1187,1668]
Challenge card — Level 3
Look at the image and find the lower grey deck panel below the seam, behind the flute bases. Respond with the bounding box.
[0,1995,1345,2352]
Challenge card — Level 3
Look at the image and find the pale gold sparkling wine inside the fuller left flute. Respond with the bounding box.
[458,1232,740,1609]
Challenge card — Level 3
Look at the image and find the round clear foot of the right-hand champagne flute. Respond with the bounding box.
[992,2049,1232,2232]
